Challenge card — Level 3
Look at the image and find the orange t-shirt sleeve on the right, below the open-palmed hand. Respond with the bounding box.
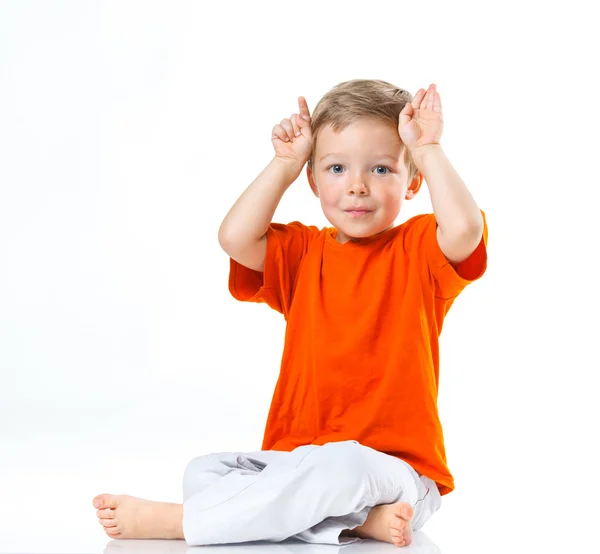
[415,210,488,299]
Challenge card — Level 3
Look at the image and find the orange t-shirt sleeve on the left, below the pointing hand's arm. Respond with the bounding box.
[229,221,319,319]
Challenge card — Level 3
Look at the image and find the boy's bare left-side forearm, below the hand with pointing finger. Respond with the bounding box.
[219,157,302,244]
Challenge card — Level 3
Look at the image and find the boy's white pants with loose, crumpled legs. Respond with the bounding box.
[183,440,441,546]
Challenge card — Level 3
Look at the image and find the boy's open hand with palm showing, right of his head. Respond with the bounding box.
[398,83,444,153]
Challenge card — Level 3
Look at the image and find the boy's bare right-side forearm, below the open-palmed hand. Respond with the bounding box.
[412,145,483,236]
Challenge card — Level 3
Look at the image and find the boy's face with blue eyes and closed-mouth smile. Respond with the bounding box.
[307,119,422,243]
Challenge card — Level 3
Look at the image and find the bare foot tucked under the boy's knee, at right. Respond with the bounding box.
[342,502,414,546]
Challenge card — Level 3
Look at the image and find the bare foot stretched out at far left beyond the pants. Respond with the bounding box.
[94,494,184,539]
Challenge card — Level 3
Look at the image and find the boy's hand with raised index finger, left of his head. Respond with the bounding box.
[271,96,312,168]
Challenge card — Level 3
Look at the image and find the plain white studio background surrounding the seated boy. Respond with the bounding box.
[0,0,600,554]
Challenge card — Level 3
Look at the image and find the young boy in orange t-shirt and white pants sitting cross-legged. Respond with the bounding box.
[94,79,487,546]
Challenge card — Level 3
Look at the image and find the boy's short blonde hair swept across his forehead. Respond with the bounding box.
[308,79,419,182]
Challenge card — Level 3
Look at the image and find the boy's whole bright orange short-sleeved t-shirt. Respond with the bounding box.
[229,211,487,495]
